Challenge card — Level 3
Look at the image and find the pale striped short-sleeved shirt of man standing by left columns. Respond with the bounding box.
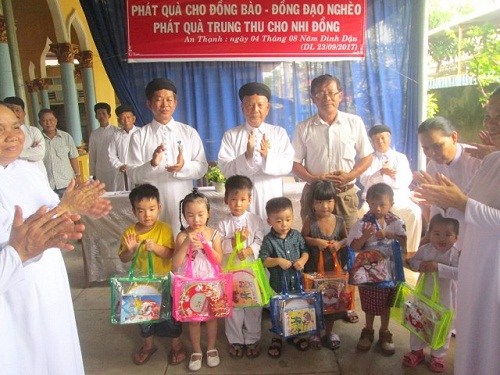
[43,129,79,189]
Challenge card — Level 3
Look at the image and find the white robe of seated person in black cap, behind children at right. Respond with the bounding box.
[359,149,413,202]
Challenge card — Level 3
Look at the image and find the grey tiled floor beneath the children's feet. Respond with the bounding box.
[65,247,454,375]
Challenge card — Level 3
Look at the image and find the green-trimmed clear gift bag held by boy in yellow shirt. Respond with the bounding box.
[110,241,171,324]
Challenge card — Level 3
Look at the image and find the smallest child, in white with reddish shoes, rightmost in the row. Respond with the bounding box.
[403,214,459,372]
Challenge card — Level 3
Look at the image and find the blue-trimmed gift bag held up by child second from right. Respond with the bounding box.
[347,240,405,288]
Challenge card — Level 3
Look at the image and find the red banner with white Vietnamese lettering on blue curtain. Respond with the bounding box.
[127,0,366,62]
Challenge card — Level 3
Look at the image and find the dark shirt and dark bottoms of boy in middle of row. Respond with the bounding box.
[259,228,309,293]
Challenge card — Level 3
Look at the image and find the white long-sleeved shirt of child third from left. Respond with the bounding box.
[218,211,266,266]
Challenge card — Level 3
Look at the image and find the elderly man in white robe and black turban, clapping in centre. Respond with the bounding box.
[218,82,293,222]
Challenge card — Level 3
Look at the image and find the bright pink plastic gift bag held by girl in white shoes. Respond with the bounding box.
[172,235,233,322]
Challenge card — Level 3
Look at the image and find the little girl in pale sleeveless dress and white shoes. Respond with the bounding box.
[173,188,222,371]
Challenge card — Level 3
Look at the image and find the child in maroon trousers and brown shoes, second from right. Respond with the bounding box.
[347,183,406,355]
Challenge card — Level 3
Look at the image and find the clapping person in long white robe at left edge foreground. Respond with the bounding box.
[0,105,111,375]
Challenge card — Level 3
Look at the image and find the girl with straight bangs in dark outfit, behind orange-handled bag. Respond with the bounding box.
[302,180,347,350]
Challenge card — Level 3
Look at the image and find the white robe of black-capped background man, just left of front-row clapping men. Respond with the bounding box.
[108,126,139,191]
